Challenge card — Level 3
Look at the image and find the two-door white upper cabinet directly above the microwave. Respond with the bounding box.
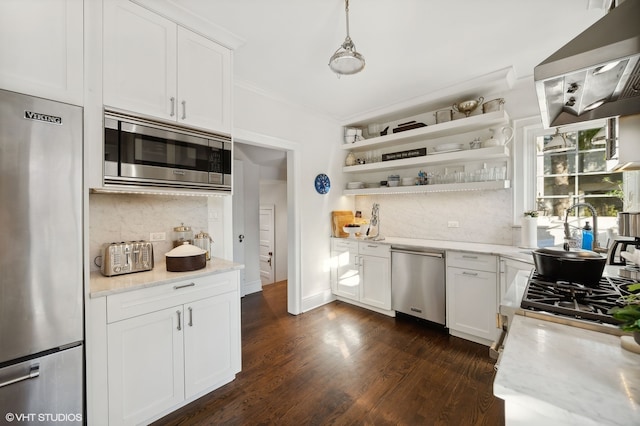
[104,0,231,134]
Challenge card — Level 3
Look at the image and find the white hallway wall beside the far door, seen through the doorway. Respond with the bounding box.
[260,181,289,282]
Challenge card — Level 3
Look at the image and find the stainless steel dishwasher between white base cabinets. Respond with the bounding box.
[391,245,446,325]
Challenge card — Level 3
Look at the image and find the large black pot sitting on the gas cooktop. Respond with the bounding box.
[533,248,607,287]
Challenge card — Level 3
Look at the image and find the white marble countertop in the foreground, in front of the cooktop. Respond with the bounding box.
[493,315,640,425]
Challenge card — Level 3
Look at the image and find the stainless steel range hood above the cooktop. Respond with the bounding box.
[534,0,640,128]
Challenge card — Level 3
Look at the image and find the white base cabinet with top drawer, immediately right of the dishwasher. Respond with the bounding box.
[446,251,499,346]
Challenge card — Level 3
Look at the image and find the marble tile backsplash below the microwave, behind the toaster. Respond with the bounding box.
[89,194,209,271]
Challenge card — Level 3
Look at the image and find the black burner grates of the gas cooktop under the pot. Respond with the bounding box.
[520,270,637,325]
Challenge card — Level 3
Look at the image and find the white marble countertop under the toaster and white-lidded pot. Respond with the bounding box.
[89,257,244,298]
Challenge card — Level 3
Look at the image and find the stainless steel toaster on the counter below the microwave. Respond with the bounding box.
[101,241,153,277]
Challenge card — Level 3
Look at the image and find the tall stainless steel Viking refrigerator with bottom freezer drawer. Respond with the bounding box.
[0,90,84,424]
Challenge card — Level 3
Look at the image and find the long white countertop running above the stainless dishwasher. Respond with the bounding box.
[334,237,533,264]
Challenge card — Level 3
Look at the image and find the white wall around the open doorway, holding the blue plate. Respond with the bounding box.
[234,84,353,311]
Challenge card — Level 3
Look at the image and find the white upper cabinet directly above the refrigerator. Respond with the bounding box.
[0,0,83,105]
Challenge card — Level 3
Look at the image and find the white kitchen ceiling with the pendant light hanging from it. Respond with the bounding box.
[148,0,607,122]
